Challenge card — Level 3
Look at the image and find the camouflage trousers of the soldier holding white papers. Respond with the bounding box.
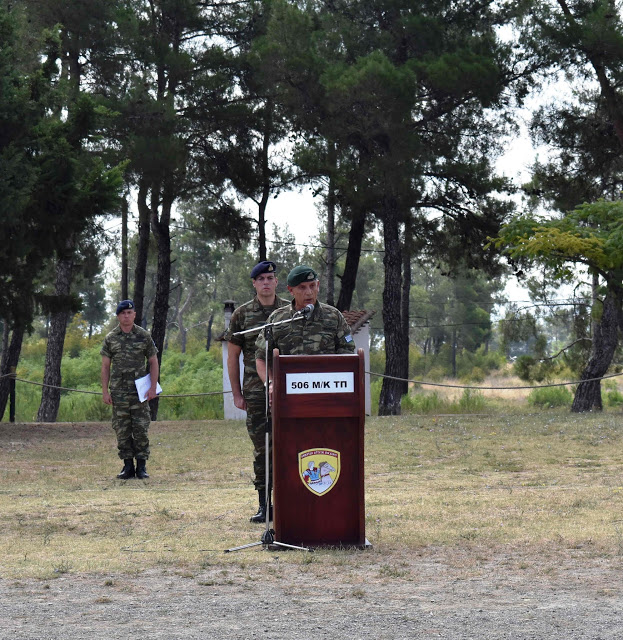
[110,390,151,460]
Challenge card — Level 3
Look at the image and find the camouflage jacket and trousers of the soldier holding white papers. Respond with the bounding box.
[100,325,158,460]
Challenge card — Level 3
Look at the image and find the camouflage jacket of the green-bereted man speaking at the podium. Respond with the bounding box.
[255,301,355,360]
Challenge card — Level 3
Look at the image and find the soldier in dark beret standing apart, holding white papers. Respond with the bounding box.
[100,300,158,480]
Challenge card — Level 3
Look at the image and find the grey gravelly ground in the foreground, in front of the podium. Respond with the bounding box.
[0,548,623,640]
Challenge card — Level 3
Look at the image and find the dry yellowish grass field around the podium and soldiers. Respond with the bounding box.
[0,412,623,580]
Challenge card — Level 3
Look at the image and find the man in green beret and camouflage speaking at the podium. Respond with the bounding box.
[255,265,355,392]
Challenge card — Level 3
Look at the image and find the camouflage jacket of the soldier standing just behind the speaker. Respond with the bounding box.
[225,296,288,393]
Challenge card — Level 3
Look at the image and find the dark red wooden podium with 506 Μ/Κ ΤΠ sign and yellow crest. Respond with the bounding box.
[272,349,366,548]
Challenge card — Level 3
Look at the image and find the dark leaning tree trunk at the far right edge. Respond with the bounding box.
[571,287,622,413]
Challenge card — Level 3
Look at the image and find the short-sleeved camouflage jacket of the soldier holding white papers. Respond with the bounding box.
[100,325,158,390]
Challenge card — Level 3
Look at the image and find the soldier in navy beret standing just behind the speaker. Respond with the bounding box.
[225,261,288,522]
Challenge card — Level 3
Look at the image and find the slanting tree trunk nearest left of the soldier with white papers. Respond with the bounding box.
[37,258,73,422]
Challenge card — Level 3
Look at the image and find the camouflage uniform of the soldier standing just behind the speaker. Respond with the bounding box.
[225,296,288,491]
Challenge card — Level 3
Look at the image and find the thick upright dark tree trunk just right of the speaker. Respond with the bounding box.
[379,205,408,416]
